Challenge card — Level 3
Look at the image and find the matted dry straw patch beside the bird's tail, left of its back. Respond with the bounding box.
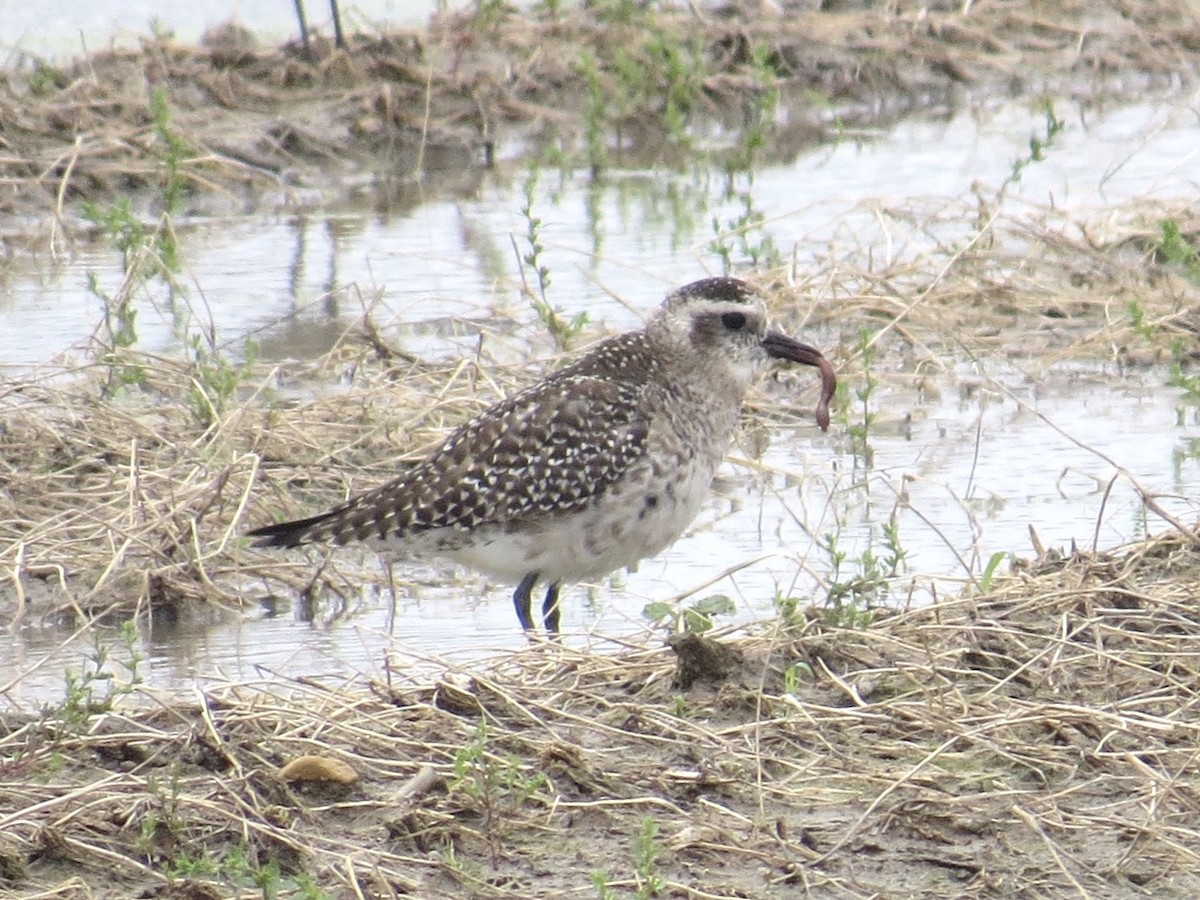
[0,331,492,622]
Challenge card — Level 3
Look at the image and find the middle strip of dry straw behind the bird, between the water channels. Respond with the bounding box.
[0,194,1200,625]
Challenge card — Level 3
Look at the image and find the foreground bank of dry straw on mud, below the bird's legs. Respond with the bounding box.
[0,533,1200,898]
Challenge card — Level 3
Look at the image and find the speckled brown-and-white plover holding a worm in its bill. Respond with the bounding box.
[247,276,836,634]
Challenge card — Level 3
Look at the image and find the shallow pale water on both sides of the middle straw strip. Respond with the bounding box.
[0,96,1200,704]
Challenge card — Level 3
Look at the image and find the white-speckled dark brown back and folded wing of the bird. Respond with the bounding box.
[278,334,654,546]
